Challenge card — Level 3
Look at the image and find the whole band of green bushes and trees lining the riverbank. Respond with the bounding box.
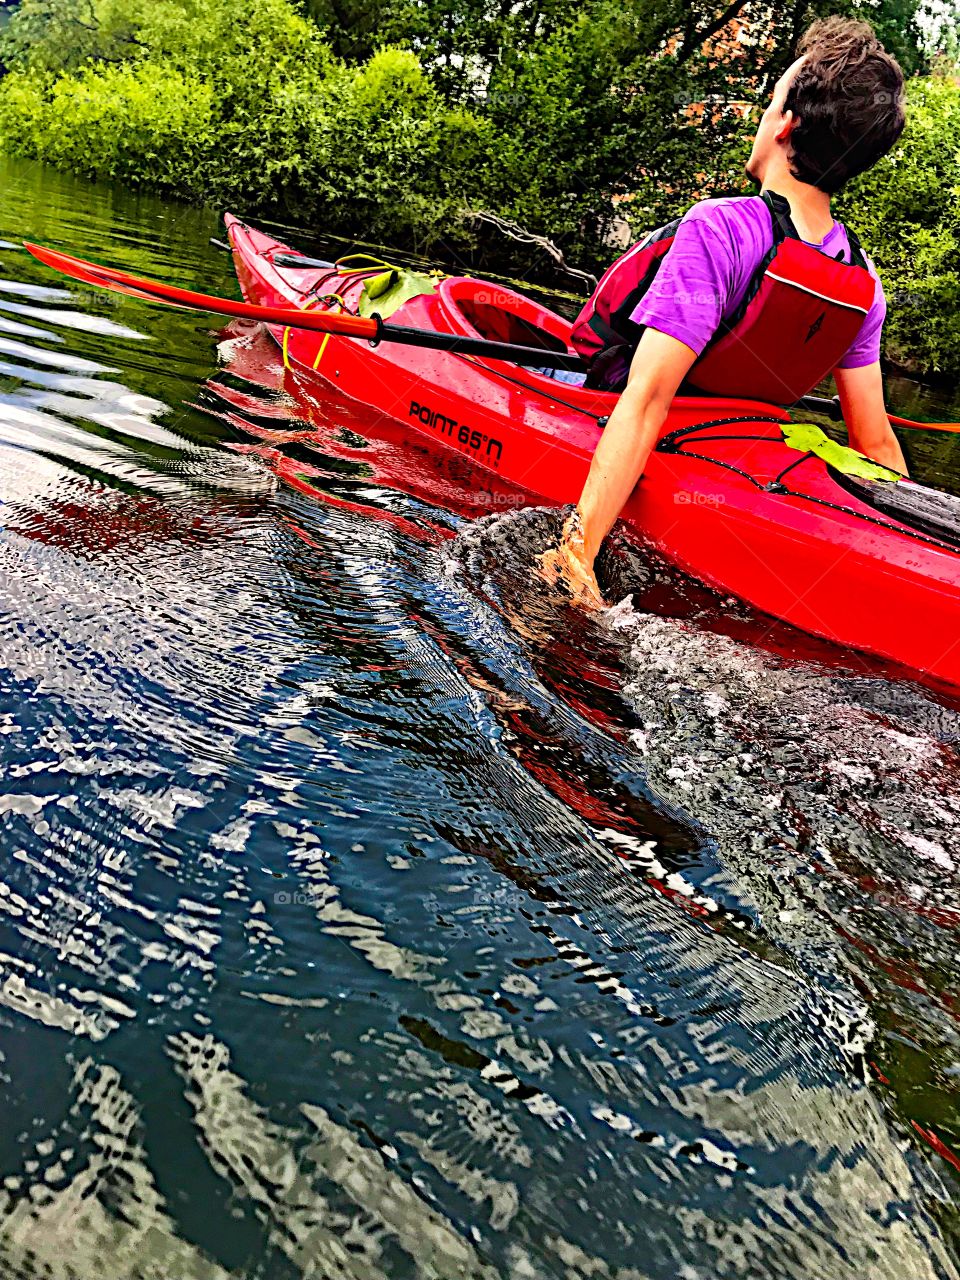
[0,0,960,372]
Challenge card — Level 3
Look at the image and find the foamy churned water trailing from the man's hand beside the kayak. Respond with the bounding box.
[447,499,960,1111]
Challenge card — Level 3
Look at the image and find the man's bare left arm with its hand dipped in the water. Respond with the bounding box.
[541,329,696,603]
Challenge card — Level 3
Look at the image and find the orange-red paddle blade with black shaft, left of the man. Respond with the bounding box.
[23,242,585,370]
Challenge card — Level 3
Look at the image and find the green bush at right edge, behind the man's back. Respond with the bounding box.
[837,76,960,378]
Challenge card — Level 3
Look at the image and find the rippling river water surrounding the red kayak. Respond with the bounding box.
[0,154,960,1280]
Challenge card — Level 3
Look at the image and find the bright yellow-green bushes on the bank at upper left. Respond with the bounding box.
[0,0,485,239]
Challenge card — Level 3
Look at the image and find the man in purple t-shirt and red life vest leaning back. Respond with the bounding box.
[541,18,906,604]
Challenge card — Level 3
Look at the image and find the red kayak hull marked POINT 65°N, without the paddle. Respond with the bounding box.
[227,215,960,686]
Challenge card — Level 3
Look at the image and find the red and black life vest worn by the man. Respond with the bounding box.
[572,192,876,404]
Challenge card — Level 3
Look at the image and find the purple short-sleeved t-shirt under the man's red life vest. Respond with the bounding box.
[630,196,887,369]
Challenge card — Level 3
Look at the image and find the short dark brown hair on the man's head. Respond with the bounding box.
[783,18,904,195]
